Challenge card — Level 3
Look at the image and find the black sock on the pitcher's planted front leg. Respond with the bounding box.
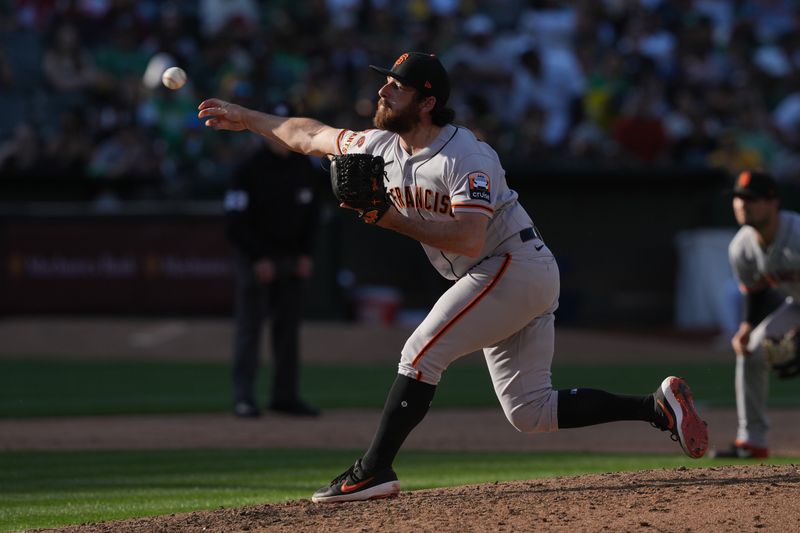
[361,374,436,472]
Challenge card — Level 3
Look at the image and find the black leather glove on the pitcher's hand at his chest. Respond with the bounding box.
[330,154,391,224]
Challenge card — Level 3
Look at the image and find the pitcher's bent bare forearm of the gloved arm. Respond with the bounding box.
[378,208,486,257]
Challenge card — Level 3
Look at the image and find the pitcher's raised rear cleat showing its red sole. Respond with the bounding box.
[653,376,708,459]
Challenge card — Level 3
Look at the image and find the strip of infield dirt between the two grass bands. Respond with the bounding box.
[0,406,800,456]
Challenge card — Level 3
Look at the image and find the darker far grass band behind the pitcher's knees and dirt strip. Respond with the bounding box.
[0,359,800,418]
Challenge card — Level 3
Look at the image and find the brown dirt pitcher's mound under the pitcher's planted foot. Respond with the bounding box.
[42,465,800,533]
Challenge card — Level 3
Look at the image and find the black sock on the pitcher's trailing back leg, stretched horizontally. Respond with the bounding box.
[558,389,655,428]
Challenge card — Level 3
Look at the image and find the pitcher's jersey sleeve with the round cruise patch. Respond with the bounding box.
[448,155,503,218]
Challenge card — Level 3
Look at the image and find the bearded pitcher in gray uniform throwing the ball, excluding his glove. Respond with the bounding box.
[198,52,708,502]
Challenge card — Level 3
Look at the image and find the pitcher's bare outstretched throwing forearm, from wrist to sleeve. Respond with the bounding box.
[244,109,338,156]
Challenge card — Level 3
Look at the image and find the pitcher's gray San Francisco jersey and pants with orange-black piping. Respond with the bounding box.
[338,125,560,432]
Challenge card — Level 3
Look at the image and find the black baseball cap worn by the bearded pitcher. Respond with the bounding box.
[369,52,450,107]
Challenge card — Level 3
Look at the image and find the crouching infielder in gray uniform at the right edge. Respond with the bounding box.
[716,171,800,458]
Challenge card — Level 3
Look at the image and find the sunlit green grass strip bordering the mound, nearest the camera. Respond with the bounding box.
[0,450,796,531]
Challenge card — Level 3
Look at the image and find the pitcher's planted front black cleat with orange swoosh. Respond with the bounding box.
[311,459,400,503]
